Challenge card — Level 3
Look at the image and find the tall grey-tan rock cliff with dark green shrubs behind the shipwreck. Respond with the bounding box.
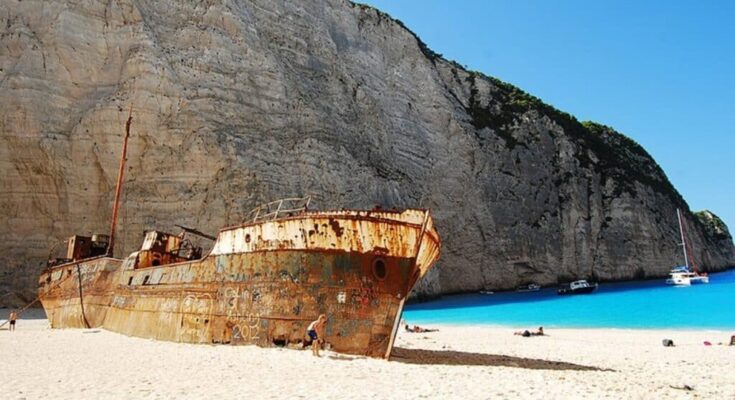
[0,0,735,304]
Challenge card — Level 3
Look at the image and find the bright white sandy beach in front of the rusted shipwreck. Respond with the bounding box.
[0,310,735,400]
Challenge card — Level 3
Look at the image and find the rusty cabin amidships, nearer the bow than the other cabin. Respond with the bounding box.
[129,231,202,269]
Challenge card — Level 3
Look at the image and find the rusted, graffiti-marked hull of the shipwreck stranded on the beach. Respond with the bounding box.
[39,210,440,357]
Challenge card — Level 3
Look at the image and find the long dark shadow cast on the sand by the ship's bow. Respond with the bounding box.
[390,347,613,371]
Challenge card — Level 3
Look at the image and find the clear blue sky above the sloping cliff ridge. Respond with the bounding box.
[362,0,735,233]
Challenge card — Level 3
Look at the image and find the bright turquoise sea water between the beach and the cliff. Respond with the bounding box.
[403,270,735,329]
